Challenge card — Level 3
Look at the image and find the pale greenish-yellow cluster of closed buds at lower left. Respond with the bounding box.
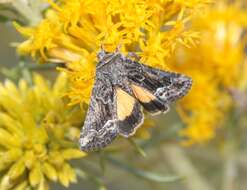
[0,73,86,190]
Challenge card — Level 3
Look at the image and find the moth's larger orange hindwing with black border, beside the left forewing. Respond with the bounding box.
[116,88,144,137]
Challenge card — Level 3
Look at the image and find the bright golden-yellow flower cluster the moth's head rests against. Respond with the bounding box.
[16,0,209,104]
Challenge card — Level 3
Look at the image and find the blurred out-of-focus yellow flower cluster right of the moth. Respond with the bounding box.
[169,1,247,144]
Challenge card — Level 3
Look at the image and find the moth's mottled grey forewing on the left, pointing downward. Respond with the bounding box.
[80,78,119,151]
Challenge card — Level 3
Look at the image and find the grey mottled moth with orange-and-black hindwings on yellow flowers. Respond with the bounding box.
[79,48,192,151]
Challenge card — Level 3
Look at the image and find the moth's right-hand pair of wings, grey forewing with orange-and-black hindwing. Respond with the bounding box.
[125,61,192,113]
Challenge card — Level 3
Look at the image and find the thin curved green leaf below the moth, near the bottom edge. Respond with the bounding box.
[107,156,183,183]
